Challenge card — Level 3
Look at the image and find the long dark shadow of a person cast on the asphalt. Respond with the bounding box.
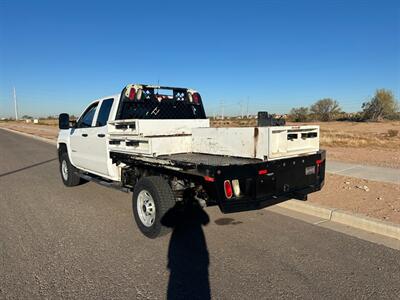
[161,201,211,299]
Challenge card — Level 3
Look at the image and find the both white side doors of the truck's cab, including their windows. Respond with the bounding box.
[70,99,114,175]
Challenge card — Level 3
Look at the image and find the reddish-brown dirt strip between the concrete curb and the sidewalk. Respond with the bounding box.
[308,174,400,224]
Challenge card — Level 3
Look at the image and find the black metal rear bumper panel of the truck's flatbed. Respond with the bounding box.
[211,150,326,213]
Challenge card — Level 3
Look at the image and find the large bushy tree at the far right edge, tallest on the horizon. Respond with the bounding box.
[361,89,398,121]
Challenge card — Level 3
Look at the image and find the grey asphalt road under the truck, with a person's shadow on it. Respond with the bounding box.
[0,130,400,299]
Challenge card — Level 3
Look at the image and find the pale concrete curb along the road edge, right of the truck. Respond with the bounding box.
[277,200,400,240]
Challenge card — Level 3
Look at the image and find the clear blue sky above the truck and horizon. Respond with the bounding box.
[0,0,400,117]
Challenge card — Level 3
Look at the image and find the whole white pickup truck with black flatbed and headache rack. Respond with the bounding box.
[57,84,325,238]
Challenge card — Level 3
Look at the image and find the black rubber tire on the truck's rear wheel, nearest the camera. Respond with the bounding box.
[132,176,175,239]
